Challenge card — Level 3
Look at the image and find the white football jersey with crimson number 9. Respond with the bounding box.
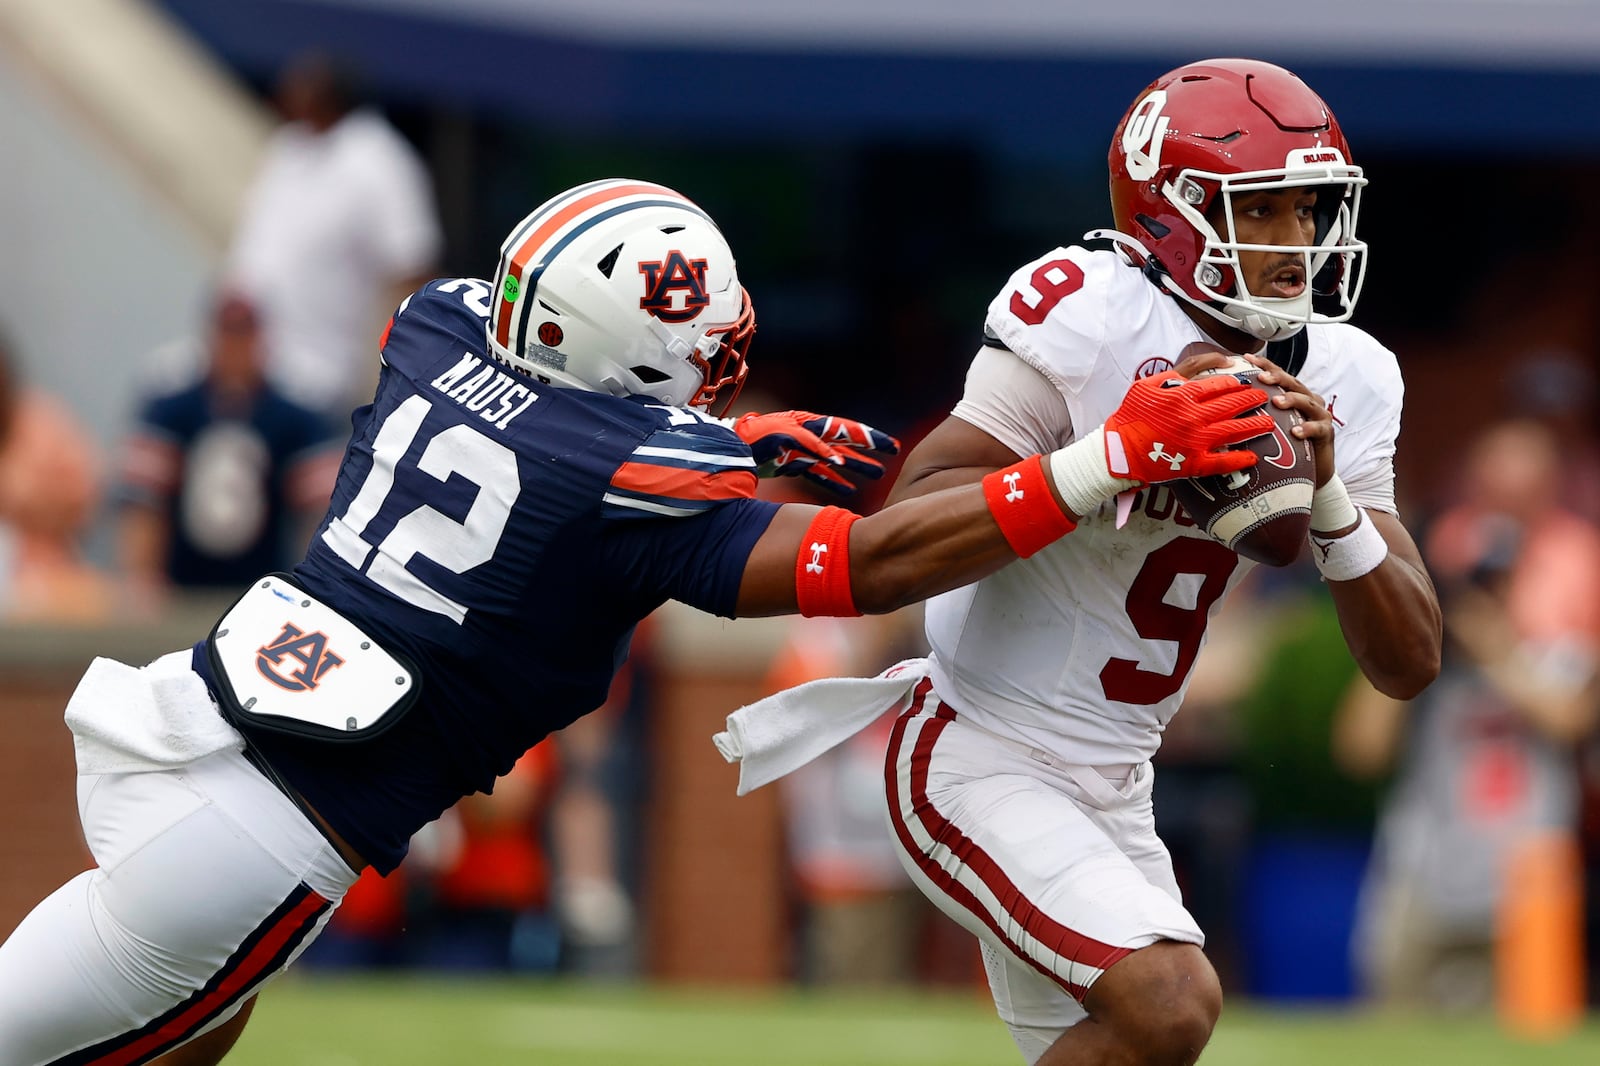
[926,246,1402,767]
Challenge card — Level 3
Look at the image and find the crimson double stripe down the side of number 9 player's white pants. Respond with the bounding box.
[885,679,1133,1000]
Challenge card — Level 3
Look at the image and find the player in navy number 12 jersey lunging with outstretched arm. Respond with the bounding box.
[0,179,1266,1066]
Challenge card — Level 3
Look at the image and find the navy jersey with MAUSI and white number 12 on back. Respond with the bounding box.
[197,279,776,872]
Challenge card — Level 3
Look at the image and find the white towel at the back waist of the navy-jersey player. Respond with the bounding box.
[66,648,245,775]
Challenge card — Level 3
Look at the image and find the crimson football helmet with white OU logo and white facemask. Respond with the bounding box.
[1088,59,1366,341]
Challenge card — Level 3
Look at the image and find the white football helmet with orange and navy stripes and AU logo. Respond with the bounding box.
[488,178,755,410]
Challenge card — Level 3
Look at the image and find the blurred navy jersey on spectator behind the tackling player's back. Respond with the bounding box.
[117,381,338,587]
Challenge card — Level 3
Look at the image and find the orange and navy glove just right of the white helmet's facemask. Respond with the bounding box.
[733,411,899,495]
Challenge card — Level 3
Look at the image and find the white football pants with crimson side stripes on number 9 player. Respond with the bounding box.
[885,680,1205,1063]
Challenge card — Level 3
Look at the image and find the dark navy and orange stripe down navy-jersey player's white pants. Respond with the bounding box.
[50,885,333,1066]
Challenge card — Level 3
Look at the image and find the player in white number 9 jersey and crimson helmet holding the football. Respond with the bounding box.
[886,59,1440,1066]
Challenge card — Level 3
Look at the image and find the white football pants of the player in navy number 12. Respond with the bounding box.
[0,751,355,1066]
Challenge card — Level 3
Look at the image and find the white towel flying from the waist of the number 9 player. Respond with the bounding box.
[710,659,930,795]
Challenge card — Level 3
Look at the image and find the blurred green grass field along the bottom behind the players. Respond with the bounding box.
[227,976,1600,1066]
